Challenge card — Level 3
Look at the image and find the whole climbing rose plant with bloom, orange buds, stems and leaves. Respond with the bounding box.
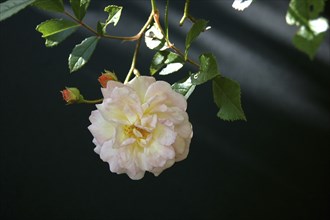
[0,0,329,180]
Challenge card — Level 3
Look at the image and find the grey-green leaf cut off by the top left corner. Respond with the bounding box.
[0,0,35,21]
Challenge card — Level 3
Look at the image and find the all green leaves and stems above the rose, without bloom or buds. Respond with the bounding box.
[0,0,328,121]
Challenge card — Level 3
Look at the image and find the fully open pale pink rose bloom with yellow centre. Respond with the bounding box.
[88,76,193,180]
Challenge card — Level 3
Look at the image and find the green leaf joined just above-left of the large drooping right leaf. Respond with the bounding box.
[191,53,220,85]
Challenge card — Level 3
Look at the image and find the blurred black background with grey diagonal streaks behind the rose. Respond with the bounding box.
[0,0,330,220]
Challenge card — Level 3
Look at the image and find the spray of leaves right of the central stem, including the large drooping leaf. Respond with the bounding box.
[150,19,246,121]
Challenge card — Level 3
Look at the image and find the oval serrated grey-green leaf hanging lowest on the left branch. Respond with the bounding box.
[69,36,99,73]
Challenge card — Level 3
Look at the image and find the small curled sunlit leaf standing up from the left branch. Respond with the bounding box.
[97,5,123,35]
